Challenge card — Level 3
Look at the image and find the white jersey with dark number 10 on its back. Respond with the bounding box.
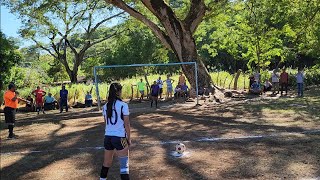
[102,100,129,137]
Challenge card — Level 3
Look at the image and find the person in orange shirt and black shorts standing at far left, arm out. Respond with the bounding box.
[3,83,28,139]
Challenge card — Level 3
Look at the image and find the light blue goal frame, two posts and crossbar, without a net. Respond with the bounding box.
[93,62,199,110]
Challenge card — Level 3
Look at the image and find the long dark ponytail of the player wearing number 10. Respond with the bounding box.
[107,83,122,118]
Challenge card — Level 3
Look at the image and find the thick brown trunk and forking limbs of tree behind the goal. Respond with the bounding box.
[105,0,211,87]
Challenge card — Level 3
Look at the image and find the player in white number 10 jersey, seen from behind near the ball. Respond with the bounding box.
[100,83,131,180]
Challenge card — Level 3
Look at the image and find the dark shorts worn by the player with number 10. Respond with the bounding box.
[104,136,128,150]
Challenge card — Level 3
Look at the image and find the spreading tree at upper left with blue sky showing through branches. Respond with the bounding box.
[5,0,122,82]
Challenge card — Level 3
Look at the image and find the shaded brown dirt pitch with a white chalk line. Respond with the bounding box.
[0,87,320,180]
